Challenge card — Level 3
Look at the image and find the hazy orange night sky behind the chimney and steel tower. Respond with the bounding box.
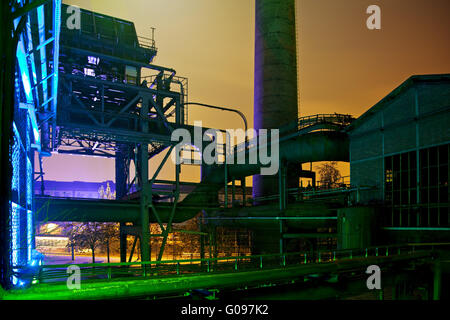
[40,0,450,181]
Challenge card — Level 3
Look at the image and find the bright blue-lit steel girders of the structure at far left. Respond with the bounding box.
[9,0,61,286]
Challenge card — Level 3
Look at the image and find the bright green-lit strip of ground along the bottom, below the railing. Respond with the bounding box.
[2,252,430,300]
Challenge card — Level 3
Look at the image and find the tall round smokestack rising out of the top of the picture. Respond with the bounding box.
[253,0,298,197]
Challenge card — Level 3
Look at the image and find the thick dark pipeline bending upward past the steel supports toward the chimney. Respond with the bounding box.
[36,131,349,224]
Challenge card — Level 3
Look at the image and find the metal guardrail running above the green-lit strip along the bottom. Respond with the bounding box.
[29,243,450,283]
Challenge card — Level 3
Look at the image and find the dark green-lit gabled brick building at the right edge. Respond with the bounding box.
[349,74,450,241]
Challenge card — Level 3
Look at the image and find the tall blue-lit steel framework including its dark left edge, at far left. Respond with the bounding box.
[0,0,61,288]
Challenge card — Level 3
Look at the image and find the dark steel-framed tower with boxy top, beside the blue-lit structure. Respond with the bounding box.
[48,5,192,261]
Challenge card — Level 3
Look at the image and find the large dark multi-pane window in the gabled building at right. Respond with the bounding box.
[384,144,450,227]
